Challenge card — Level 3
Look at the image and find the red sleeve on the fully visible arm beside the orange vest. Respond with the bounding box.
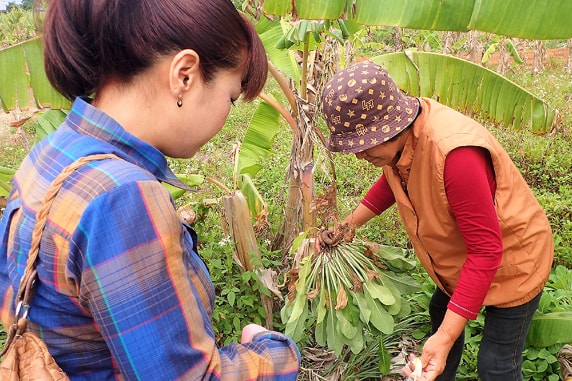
[444,147,503,319]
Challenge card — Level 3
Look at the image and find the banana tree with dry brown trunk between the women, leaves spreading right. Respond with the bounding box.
[246,0,572,251]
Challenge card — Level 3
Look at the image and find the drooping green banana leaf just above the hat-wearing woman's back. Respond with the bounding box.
[372,52,556,134]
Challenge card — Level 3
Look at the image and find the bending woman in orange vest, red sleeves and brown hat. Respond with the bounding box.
[322,62,554,381]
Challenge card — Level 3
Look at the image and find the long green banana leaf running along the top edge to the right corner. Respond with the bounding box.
[263,0,572,40]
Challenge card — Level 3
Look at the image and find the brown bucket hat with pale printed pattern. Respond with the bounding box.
[322,61,419,153]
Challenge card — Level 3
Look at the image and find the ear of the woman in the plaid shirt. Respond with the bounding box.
[169,49,201,96]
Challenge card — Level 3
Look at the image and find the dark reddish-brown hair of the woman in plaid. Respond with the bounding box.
[44,0,268,100]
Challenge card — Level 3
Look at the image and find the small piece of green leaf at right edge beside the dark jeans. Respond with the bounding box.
[526,311,572,348]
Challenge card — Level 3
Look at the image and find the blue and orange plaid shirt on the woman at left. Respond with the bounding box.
[0,98,300,381]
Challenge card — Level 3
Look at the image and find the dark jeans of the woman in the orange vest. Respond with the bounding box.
[429,288,542,381]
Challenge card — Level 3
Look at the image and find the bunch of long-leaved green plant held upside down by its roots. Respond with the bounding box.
[281,223,418,355]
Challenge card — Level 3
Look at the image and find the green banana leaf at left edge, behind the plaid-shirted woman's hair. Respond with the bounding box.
[0,38,70,112]
